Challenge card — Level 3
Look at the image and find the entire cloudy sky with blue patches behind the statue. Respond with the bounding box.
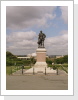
[6,6,68,55]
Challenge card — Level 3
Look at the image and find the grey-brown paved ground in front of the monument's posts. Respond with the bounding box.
[6,71,68,90]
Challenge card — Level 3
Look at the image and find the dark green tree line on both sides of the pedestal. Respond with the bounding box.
[6,51,68,66]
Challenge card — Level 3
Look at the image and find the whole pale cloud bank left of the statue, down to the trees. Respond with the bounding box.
[6,31,37,54]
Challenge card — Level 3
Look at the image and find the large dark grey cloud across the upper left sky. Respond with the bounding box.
[6,6,56,29]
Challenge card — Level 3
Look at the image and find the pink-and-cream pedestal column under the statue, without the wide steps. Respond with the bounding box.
[34,48,47,68]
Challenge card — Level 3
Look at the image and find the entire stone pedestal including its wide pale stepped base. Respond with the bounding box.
[24,48,56,74]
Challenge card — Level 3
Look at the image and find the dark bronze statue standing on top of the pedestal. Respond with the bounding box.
[37,31,46,48]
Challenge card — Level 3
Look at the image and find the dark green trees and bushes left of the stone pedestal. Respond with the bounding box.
[6,51,36,66]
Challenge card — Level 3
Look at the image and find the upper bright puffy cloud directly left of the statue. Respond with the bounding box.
[6,31,37,43]
